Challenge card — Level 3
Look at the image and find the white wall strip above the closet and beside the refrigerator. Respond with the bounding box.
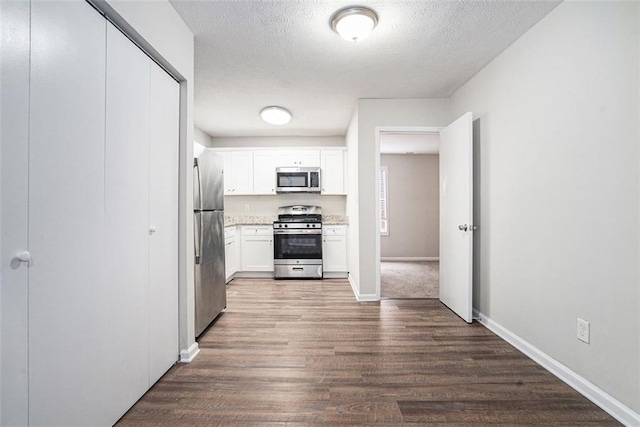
[102,0,195,356]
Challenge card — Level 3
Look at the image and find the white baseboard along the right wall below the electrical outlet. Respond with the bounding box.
[473,309,640,426]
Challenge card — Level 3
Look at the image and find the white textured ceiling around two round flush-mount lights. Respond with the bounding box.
[170,0,559,136]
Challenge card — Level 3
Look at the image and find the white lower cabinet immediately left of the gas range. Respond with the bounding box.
[240,225,273,272]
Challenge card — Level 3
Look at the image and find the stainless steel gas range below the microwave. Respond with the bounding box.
[273,205,322,279]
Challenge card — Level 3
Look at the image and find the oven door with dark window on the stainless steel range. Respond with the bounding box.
[273,229,322,264]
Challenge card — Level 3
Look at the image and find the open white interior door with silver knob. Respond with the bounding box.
[440,113,473,323]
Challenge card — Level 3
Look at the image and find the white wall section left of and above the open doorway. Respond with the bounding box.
[356,99,449,297]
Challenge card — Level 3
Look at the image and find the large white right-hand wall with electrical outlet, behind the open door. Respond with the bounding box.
[449,2,640,412]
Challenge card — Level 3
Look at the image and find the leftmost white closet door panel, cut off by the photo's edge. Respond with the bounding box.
[0,1,31,426]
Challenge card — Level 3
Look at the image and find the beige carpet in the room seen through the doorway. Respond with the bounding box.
[380,261,440,298]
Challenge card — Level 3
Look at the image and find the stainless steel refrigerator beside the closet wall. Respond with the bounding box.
[193,150,227,336]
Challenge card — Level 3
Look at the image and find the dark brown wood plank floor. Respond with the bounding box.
[118,279,619,426]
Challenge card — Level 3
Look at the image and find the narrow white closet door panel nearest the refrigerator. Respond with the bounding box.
[149,63,180,385]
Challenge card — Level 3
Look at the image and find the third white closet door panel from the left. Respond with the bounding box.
[104,24,151,414]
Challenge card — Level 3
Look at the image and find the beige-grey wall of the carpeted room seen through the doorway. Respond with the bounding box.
[380,154,440,258]
